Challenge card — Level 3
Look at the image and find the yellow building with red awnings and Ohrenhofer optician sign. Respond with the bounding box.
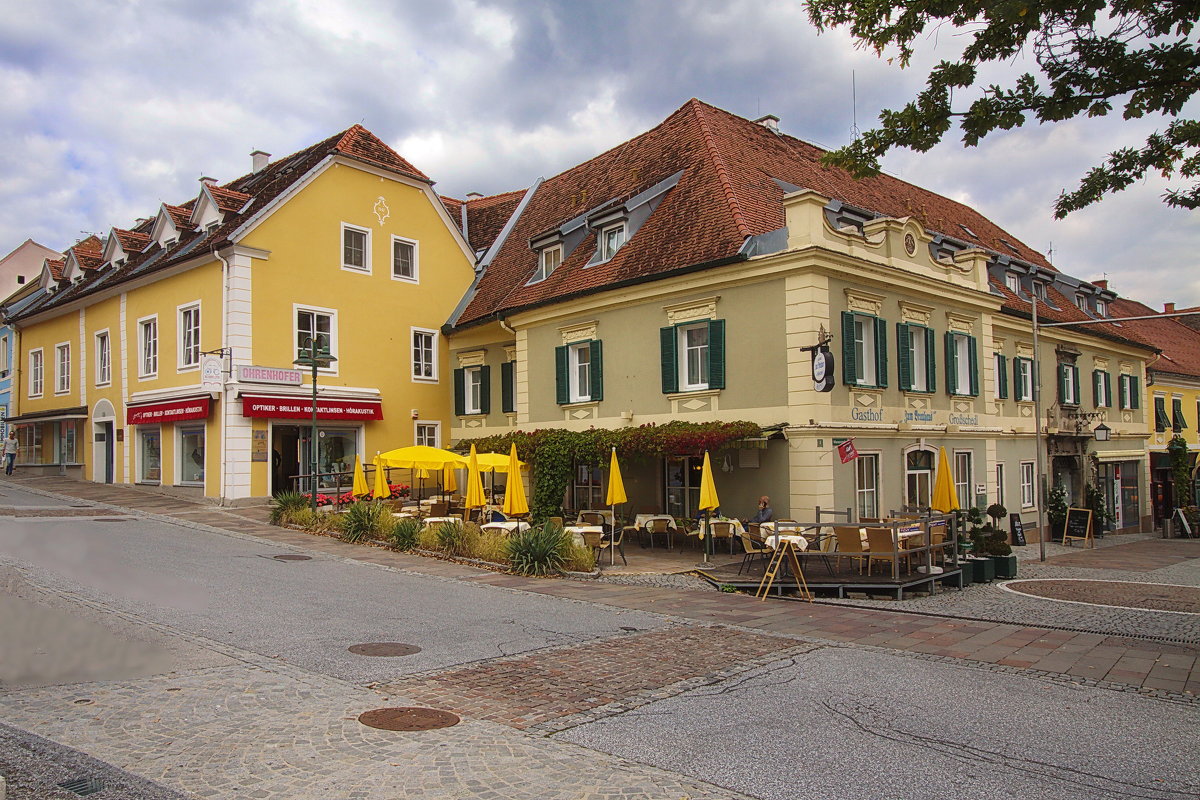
[7,126,474,503]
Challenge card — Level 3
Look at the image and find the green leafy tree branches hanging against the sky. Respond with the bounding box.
[808,0,1200,218]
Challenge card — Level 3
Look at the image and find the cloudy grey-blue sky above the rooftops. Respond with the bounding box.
[0,0,1200,305]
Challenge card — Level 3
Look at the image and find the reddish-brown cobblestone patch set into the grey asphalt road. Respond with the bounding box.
[380,627,799,729]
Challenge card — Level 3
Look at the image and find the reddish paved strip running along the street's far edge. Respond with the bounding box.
[7,477,1200,702]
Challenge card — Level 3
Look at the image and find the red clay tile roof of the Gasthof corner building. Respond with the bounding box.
[456,100,1052,325]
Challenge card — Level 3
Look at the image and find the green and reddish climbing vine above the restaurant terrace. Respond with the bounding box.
[455,421,762,521]
